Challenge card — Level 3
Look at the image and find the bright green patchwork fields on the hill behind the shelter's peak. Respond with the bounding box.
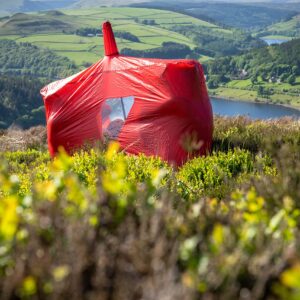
[0,8,225,65]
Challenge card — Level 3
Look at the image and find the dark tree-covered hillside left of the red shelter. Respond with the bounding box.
[0,40,79,129]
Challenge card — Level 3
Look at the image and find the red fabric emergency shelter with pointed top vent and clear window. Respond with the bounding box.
[41,22,213,166]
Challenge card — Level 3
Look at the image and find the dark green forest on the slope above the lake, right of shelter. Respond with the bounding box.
[205,39,300,87]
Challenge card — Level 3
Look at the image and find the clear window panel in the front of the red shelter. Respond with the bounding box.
[101,96,134,139]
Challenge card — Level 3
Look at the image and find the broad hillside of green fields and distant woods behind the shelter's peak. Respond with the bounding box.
[0,7,263,65]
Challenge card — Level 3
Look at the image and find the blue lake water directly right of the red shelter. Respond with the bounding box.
[210,97,300,119]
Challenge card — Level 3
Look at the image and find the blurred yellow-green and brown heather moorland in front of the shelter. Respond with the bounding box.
[0,117,300,300]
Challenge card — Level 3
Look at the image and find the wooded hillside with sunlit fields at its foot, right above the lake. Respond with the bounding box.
[206,39,300,107]
